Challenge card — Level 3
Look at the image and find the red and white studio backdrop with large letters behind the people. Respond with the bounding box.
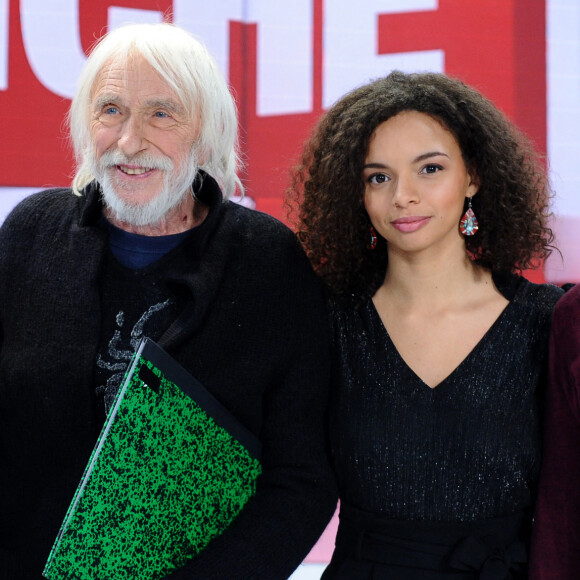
[0,0,580,580]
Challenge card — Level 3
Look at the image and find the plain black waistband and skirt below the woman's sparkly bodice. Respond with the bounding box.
[323,505,530,580]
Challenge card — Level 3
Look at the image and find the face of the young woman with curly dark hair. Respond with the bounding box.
[363,111,477,254]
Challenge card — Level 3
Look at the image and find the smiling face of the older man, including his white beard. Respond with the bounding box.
[90,56,199,225]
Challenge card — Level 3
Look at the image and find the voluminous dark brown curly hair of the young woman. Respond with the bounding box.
[287,71,553,296]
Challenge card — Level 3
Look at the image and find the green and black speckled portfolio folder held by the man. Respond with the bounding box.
[43,339,261,580]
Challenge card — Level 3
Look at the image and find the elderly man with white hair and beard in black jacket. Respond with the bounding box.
[0,24,335,580]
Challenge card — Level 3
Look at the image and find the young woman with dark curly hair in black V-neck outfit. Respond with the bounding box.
[291,72,562,580]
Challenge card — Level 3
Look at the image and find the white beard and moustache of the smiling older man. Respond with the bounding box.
[90,150,199,227]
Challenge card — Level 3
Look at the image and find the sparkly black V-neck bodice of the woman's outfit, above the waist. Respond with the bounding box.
[330,275,562,522]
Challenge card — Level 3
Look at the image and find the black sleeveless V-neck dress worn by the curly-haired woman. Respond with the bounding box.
[324,275,562,580]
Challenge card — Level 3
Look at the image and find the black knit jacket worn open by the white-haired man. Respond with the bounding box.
[0,177,336,580]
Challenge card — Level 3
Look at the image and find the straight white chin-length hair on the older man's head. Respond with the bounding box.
[68,23,243,199]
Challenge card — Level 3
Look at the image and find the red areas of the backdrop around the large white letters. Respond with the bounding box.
[0,0,546,280]
